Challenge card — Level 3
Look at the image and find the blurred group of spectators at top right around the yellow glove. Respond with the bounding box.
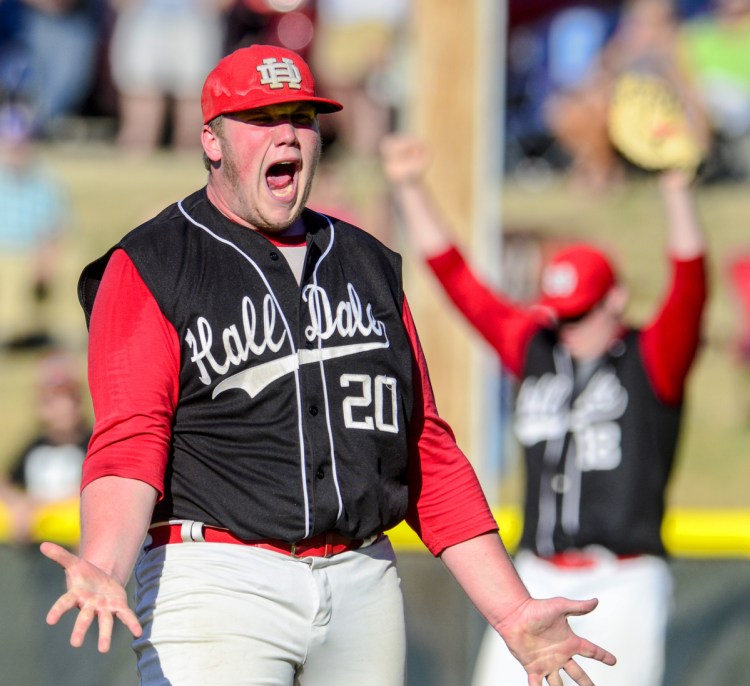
[506,0,750,191]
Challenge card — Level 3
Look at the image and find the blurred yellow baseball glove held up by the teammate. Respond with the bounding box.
[607,72,706,172]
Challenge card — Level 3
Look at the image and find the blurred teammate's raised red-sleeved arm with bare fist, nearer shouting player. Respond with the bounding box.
[381,134,542,377]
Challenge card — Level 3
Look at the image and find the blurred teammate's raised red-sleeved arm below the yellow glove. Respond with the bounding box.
[641,170,707,404]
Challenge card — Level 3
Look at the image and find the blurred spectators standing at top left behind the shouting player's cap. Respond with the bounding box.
[0,0,410,152]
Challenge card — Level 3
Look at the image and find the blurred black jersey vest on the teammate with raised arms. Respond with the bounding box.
[515,330,682,555]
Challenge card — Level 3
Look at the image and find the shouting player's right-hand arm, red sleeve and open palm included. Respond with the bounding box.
[403,300,614,686]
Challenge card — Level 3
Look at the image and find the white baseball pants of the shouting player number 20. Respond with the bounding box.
[133,537,406,686]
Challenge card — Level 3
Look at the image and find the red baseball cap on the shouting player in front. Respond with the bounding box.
[201,45,343,124]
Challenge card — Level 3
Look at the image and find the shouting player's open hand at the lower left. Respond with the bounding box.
[40,542,142,653]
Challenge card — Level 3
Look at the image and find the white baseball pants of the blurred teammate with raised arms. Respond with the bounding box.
[472,550,673,686]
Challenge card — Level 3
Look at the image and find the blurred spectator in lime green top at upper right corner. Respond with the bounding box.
[680,0,750,178]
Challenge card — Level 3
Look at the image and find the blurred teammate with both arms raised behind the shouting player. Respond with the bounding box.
[382,135,706,686]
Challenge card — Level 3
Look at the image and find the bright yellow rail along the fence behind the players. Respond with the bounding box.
[0,500,750,558]
